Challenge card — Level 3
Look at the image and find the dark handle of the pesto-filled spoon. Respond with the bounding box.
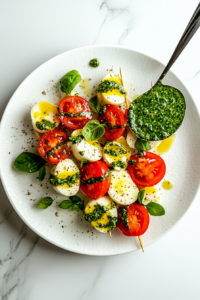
[155,3,200,85]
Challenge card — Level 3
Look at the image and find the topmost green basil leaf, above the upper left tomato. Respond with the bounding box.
[60,70,81,95]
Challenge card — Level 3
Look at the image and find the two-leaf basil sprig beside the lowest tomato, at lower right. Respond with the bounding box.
[138,189,165,216]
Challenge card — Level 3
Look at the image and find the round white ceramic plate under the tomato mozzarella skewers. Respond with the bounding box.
[0,46,200,255]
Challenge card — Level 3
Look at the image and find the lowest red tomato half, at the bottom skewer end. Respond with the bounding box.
[117,203,149,236]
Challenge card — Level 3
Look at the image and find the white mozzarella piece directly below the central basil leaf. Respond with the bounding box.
[68,129,103,161]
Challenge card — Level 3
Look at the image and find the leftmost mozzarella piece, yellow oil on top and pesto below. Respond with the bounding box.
[31,101,60,133]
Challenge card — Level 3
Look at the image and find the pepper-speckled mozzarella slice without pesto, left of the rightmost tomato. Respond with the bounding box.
[108,171,139,205]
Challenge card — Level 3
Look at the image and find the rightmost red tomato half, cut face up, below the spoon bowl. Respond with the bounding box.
[128,152,166,187]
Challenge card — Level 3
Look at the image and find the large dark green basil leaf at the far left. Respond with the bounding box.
[14,152,46,173]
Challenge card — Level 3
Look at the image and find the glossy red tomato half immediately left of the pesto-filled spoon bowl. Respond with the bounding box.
[98,104,126,141]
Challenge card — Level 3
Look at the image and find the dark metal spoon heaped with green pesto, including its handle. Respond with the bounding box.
[128,3,200,141]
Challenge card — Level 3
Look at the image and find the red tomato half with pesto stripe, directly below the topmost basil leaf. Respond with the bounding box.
[58,96,92,129]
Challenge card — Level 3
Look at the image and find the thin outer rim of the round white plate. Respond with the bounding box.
[0,44,200,256]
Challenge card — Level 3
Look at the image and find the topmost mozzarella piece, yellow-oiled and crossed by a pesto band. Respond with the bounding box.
[97,73,125,105]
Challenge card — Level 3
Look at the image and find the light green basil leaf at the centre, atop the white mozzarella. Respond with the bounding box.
[82,120,105,141]
